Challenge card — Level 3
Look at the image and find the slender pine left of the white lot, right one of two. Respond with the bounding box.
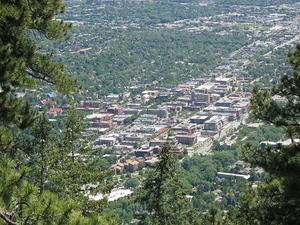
[49,105,112,214]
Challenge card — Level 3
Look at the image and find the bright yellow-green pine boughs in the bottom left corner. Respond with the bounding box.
[0,130,117,225]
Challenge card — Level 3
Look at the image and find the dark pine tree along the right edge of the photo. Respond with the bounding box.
[231,45,300,225]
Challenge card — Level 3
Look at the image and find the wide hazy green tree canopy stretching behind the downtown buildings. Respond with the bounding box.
[43,0,249,95]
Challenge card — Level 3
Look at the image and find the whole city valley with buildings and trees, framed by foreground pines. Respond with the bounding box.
[0,0,300,224]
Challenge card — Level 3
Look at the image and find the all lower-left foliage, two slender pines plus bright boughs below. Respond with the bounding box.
[0,109,117,224]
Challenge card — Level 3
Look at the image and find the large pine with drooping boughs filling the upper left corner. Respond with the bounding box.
[0,0,74,149]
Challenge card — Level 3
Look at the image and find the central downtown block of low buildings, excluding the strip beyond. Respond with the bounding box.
[79,73,250,172]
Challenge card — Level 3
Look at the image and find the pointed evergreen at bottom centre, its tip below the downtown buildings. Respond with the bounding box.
[136,145,199,225]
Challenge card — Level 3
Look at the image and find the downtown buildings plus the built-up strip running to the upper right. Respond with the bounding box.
[32,0,299,176]
